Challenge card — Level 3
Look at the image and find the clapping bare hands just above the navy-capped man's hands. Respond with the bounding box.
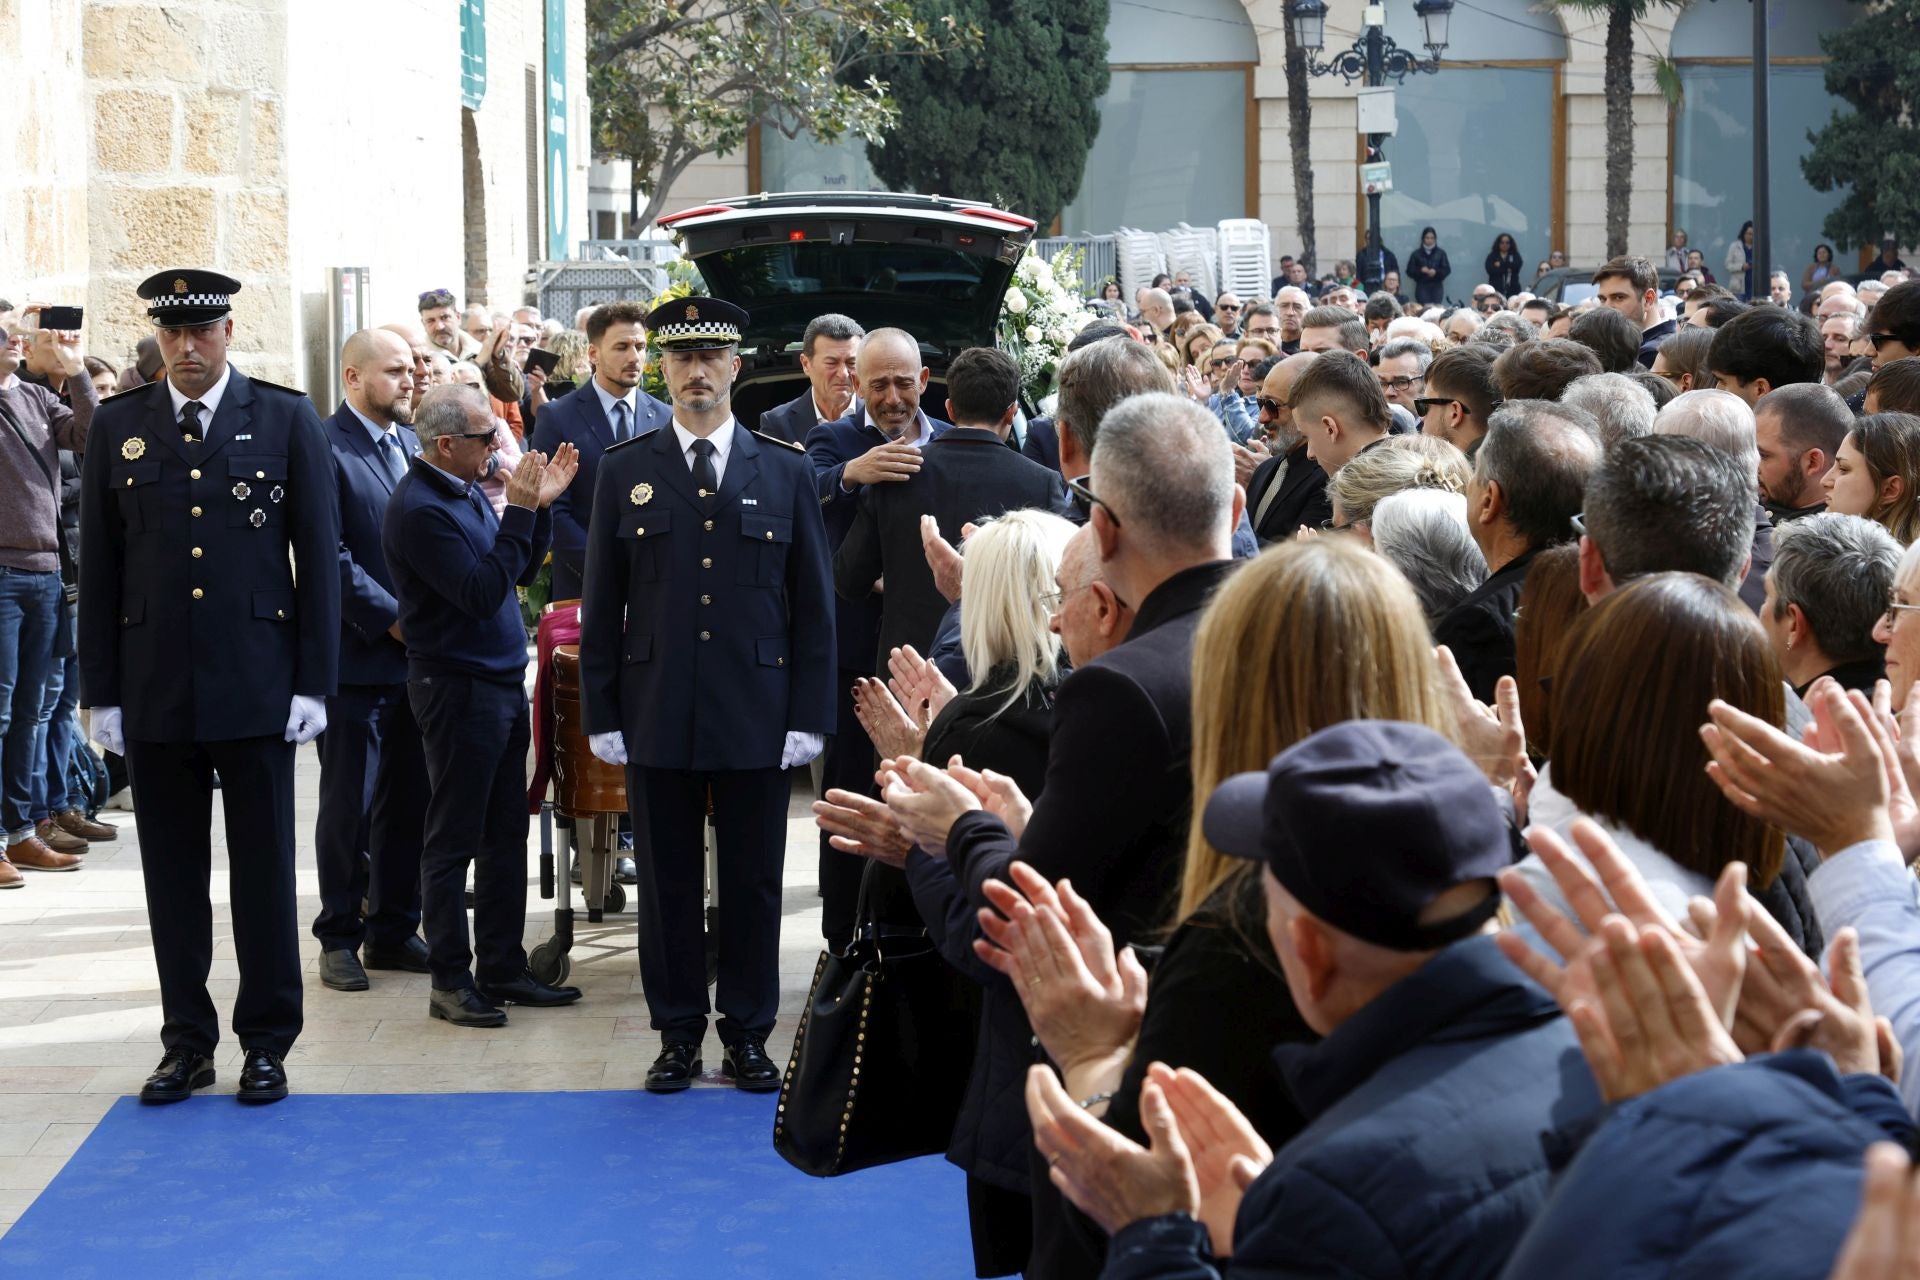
[973,862,1146,1094]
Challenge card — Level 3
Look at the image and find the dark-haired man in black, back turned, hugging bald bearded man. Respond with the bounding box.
[833,347,1068,672]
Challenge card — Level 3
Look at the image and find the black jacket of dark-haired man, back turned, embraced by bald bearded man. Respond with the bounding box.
[833,426,1068,672]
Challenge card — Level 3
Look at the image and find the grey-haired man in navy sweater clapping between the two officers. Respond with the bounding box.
[380,386,580,1027]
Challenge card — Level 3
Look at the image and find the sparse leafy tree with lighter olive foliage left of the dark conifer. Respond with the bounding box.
[588,0,979,223]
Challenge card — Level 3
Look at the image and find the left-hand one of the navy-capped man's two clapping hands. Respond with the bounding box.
[1027,1067,1200,1236]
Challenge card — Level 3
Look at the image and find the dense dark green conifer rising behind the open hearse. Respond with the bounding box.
[868,0,1113,226]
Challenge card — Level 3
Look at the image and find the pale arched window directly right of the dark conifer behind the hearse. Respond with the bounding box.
[1060,0,1260,236]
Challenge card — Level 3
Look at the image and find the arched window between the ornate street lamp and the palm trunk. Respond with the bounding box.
[1374,0,1567,299]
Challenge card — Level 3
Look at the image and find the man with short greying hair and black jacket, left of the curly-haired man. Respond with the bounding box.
[1434,399,1599,702]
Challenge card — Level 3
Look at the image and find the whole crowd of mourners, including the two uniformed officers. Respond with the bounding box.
[11,238,1920,1280]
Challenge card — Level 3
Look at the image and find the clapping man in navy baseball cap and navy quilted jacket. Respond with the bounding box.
[1027,720,1599,1280]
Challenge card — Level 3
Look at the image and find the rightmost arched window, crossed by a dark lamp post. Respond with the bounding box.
[1670,0,1859,297]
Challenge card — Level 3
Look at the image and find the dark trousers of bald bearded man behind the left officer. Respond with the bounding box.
[313,683,428,952]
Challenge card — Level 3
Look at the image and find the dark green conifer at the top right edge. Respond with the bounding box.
[1801,0,1920,248]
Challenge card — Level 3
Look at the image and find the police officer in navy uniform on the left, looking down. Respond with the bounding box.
[81,271,340,1102]
